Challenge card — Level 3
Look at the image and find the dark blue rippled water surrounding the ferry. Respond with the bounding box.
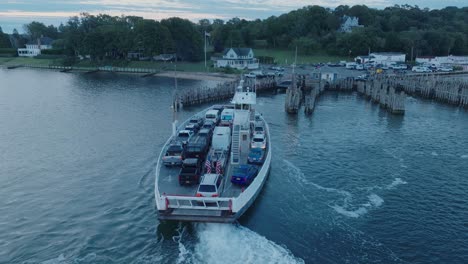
[0,69,468,263]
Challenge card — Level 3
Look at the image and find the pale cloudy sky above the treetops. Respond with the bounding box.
[0,0,468,33]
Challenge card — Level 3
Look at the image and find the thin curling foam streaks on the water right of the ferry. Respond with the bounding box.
[283,160,407,218]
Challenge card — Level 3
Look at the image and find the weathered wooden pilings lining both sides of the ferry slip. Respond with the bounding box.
[174,74,468,114]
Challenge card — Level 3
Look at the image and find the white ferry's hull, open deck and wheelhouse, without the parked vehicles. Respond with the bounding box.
[155,81,271,223]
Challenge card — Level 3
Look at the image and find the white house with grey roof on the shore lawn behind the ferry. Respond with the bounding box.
[216,48,259,70]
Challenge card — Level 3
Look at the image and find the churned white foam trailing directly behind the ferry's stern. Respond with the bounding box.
[189,224,304,264]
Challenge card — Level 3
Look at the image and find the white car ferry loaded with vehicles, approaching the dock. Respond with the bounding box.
[155,80,271,223]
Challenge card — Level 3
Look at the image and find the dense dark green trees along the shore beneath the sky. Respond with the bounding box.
[0,5,468,61]
